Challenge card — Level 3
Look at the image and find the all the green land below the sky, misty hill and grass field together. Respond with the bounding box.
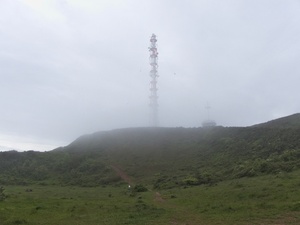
[0,114,300,225]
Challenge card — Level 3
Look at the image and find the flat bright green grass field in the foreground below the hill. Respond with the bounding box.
[0,171,300,225]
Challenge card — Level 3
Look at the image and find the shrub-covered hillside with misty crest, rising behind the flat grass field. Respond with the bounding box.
[0,114,300,188]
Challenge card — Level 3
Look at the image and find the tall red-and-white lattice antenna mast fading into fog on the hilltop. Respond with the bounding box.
[149,34,158,127]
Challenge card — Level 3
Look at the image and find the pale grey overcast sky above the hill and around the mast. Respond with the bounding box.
[0,0,300,151]
